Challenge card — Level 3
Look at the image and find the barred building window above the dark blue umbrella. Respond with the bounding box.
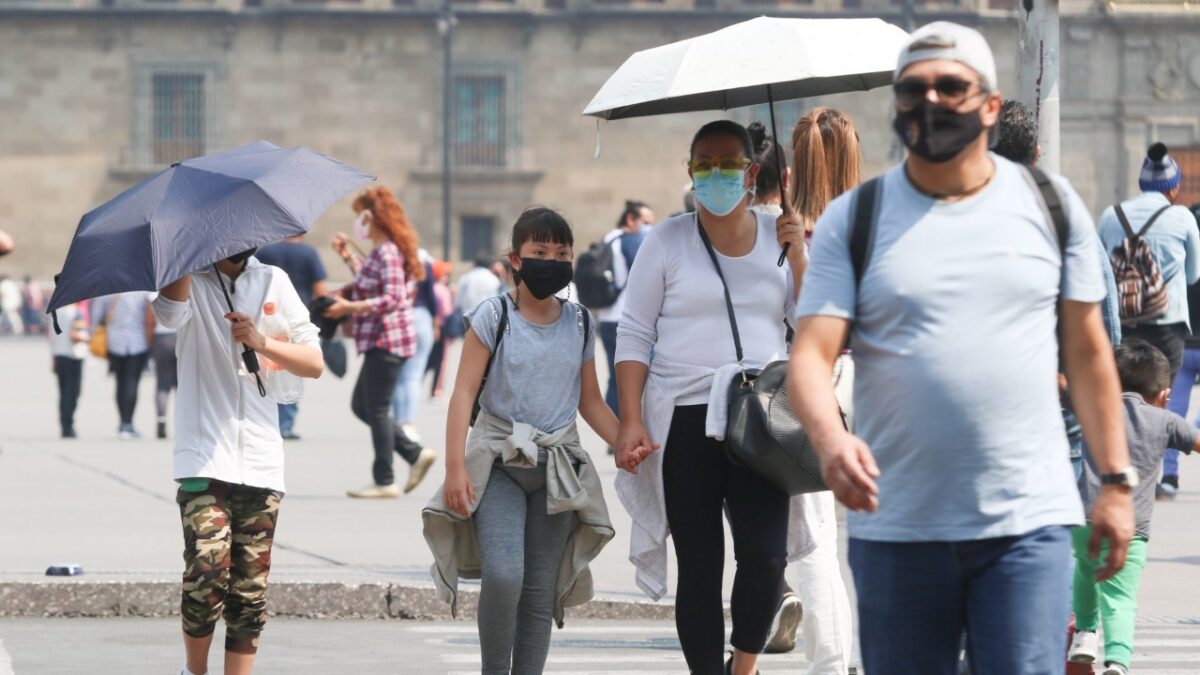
[151,73,206,165]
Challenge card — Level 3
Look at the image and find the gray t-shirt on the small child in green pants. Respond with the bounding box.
[1079,392,1198,539]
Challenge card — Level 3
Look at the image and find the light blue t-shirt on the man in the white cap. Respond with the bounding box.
[797,155,1105,542]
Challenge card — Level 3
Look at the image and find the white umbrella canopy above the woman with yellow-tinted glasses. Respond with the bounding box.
[583,17,908,120]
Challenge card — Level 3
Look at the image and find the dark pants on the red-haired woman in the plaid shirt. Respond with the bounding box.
[350,350,421,485]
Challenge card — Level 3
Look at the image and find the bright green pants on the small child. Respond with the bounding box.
[1070,525,1146,668]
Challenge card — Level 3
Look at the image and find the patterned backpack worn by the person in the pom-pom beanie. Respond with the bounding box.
[1109,204,1170,325]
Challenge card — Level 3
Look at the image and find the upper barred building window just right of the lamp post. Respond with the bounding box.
[454,74,508,167]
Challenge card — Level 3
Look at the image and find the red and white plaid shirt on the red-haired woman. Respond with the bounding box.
[346,241,416,359]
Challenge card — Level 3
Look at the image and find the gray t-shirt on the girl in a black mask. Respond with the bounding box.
[467,295,595,432]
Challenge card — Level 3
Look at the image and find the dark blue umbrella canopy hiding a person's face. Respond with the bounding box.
[47,141,374,312]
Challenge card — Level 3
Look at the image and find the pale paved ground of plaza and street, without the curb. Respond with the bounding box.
[0,339,1200,675]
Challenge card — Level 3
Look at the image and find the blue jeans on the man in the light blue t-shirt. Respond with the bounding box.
[850,526,1072,675]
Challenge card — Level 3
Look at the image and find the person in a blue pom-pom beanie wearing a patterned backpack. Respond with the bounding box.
[1097,143,1200,497]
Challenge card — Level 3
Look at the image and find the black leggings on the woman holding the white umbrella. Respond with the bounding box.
[662,405,788,675]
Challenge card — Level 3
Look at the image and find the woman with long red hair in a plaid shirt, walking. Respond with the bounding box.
[325,186,439,498]
